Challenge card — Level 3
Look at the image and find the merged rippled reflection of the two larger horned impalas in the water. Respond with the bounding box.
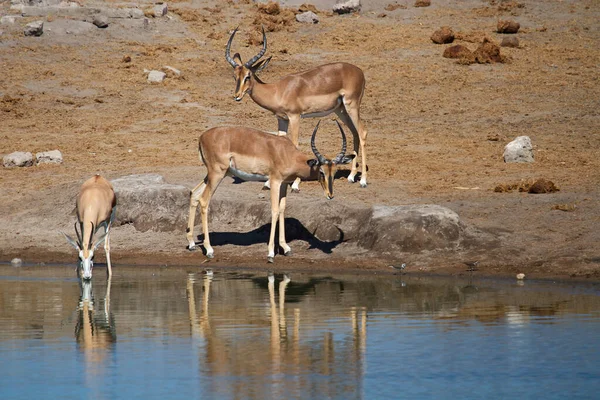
[187,274,367,398]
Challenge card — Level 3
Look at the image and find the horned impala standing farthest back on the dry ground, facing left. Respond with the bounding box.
[225,28,367,191]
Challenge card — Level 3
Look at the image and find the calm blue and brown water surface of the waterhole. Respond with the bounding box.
[0,265,600,399]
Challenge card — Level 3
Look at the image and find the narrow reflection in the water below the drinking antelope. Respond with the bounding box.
[75,278,117,380]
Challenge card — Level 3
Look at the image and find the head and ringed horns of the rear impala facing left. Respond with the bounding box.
[225,27,271,101]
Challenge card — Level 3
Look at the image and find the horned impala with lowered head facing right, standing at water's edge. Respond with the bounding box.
[187,121,354,262]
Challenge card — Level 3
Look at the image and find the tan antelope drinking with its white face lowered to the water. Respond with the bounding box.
[63,175,117,279]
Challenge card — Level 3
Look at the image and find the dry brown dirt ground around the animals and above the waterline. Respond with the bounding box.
[0,0,600,280]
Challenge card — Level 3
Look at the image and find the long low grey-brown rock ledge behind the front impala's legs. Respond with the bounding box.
[112,174,486,254]
